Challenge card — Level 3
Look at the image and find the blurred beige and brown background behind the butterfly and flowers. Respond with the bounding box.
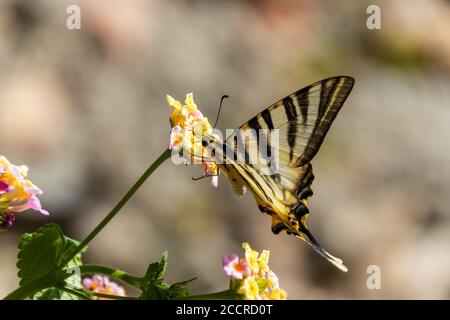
[0,0,450,299]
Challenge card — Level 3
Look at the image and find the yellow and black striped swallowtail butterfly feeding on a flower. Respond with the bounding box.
[203,76,355,272]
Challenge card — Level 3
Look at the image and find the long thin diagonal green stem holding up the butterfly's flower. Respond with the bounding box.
[60,149,171,269]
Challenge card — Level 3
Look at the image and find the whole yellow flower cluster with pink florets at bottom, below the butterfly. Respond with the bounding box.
[223,242,287,300]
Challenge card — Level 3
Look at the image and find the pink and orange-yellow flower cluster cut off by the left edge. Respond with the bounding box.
[0,156,48,229]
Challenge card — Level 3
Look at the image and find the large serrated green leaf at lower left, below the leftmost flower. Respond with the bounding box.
[17,224,65,286]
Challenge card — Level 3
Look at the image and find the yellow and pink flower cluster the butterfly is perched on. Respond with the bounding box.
[167,93,219,187]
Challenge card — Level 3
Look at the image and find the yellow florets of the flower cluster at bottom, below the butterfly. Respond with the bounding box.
[231,243,287,300]
